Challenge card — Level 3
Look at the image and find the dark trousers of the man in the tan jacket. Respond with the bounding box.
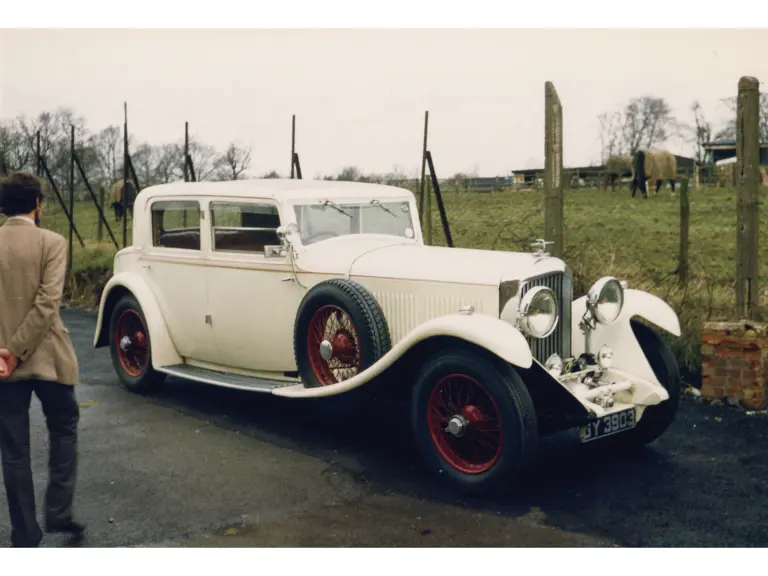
[0,380,80,547]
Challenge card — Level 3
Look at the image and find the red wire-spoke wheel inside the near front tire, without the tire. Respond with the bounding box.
[427,374,503,474]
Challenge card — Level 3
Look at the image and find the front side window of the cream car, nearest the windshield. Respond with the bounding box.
[211,202,280,254]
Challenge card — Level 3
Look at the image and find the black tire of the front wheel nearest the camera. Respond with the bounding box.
[411,348,539,494]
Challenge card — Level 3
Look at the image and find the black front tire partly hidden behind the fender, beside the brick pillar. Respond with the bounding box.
[617,320,682,446]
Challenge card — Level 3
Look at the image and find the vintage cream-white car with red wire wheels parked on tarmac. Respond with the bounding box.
[94,179,681,491]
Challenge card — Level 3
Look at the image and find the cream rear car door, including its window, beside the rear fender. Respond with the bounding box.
[139,197,217,361]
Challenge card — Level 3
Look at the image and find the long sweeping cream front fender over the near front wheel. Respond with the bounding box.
[273,314,533,398]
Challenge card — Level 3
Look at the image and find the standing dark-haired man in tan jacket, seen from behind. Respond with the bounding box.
[0,173,85,547]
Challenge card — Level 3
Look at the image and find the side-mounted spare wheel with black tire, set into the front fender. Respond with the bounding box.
[293,278,391,388]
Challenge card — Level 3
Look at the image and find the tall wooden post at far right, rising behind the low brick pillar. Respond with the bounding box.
[736,76,760,320]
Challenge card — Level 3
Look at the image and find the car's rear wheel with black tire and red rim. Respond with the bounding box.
[109,294,165,394]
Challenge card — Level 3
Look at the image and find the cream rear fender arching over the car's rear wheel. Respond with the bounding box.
[93,272,184,368]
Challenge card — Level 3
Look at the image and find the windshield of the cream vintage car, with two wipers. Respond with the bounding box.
[294,199,415,246]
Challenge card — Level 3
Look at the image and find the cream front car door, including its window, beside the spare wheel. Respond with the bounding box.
[207,198,304,373]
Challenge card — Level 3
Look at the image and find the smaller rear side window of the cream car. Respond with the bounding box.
[152,200,200,250]
